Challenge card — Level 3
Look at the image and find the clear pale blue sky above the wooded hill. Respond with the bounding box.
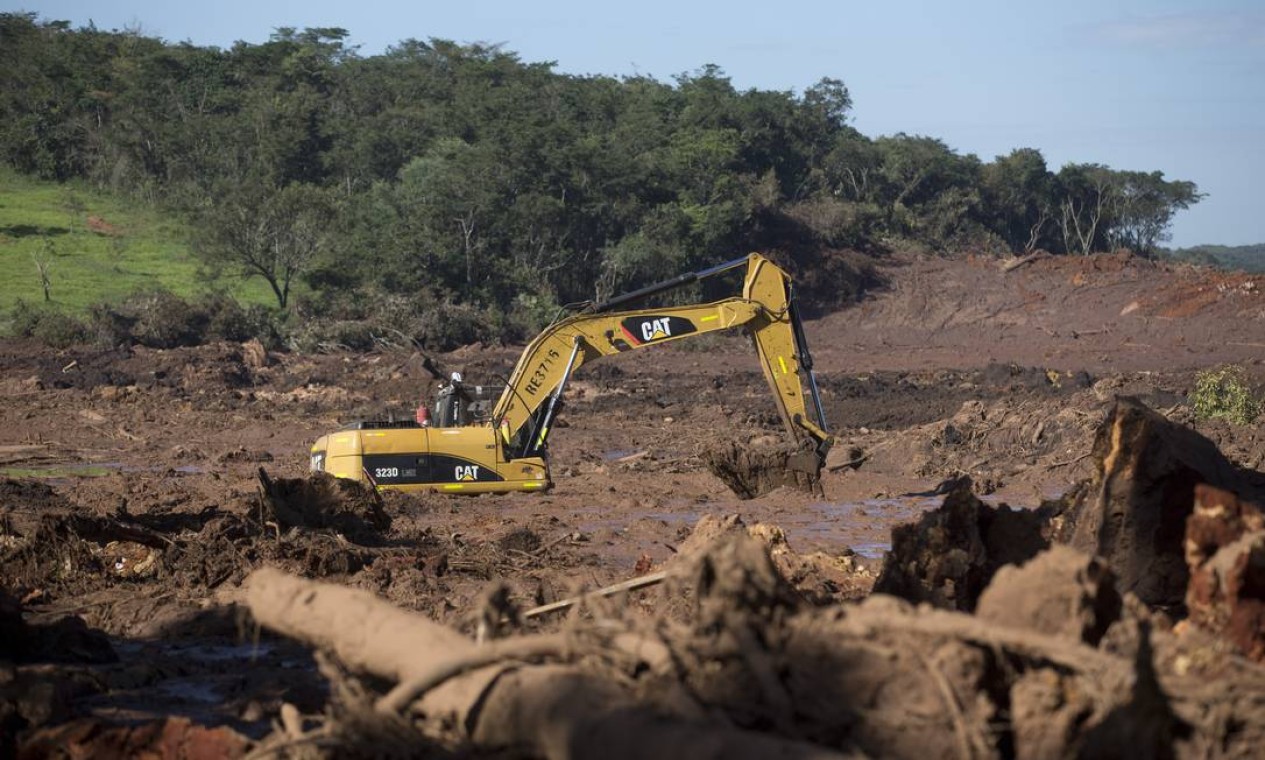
[12,0,1265,245]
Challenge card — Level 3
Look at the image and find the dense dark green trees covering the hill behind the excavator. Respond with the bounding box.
[0,14,1200,341]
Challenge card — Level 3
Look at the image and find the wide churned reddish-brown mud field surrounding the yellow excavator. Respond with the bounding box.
[0,255,1265,757]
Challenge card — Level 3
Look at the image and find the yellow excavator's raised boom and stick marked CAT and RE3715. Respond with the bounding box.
[492,253,832,467]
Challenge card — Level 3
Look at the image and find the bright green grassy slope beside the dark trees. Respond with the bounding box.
[0,167,275,314]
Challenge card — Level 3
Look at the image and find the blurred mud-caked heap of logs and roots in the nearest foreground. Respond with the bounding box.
[239,515,1265,759]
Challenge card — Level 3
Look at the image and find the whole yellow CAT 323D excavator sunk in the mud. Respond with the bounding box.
[311,253,832,493]
